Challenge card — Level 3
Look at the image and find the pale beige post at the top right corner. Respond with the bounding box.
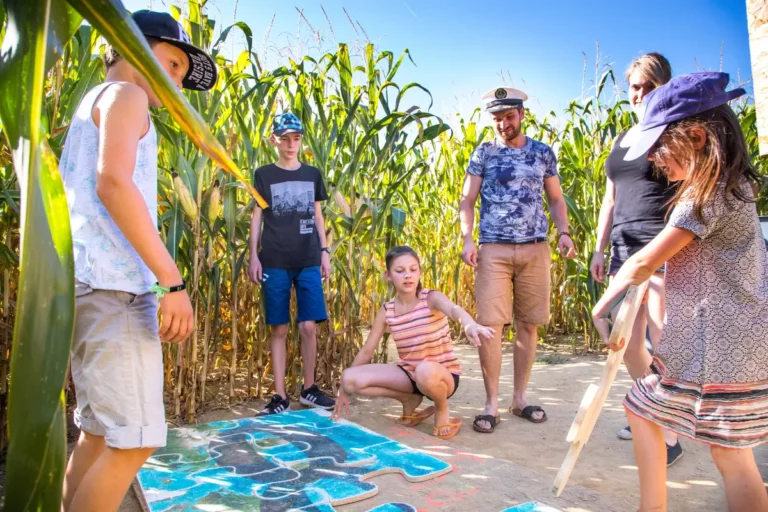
[747,0,768,155]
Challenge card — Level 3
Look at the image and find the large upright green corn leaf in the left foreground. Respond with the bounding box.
[0,0,80,511]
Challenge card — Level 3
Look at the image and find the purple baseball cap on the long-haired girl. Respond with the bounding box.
[621,71,746,161]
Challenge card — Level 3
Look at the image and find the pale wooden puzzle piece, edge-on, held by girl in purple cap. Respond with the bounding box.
[552,281,648,496]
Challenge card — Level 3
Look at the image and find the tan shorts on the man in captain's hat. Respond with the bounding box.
[475,242,552,325]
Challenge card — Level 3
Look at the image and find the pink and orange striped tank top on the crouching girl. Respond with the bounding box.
[384,290,461,378]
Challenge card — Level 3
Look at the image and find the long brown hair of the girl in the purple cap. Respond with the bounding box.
[651,105,760,222]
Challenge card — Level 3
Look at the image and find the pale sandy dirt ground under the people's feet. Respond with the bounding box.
[114,344,768,512]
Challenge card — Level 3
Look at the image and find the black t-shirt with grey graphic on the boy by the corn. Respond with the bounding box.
[253,164,328,268]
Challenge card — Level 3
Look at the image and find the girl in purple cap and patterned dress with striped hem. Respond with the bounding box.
[592,72,768,512]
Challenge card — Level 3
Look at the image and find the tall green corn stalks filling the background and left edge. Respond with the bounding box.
[0,0,768,510]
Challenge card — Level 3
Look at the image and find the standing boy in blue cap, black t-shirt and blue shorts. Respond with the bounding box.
[248,112,336,415]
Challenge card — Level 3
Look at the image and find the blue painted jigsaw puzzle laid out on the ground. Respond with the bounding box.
[138,409,452,512]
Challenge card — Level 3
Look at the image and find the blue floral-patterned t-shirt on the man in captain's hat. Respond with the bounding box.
[467,137,558,244]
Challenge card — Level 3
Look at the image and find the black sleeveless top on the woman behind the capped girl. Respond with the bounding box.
[605,132,677,248]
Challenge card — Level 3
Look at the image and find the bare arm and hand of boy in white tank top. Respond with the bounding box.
[94,83,194,343]
